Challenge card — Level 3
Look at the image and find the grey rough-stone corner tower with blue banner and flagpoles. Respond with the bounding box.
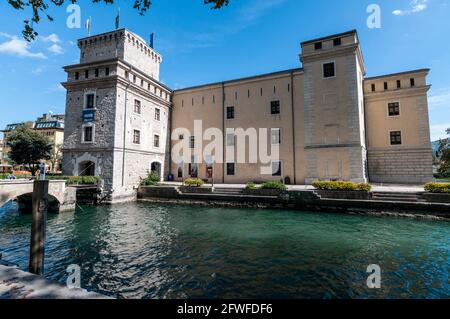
[62,29,171,202]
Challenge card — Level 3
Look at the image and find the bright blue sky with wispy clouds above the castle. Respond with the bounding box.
[0,0,450,140]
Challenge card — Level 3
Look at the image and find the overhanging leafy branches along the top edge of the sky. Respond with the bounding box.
[7,0,229,41]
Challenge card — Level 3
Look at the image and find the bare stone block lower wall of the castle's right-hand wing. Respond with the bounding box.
[368,148,433,184]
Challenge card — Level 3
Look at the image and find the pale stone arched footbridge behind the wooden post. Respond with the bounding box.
[0,180,76,213]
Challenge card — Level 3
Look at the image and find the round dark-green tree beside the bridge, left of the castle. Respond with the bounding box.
[7,125,53,171]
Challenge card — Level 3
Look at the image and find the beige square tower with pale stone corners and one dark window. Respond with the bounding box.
[301,31,367,183]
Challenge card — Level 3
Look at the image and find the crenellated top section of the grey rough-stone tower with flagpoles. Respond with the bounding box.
[78,29,162,80]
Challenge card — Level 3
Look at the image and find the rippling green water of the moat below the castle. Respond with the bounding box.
[0,203,450,298]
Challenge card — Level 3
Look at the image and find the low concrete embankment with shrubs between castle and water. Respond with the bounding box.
[138,186,450,219]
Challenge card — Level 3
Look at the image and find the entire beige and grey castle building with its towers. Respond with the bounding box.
[59,29,432,200]
